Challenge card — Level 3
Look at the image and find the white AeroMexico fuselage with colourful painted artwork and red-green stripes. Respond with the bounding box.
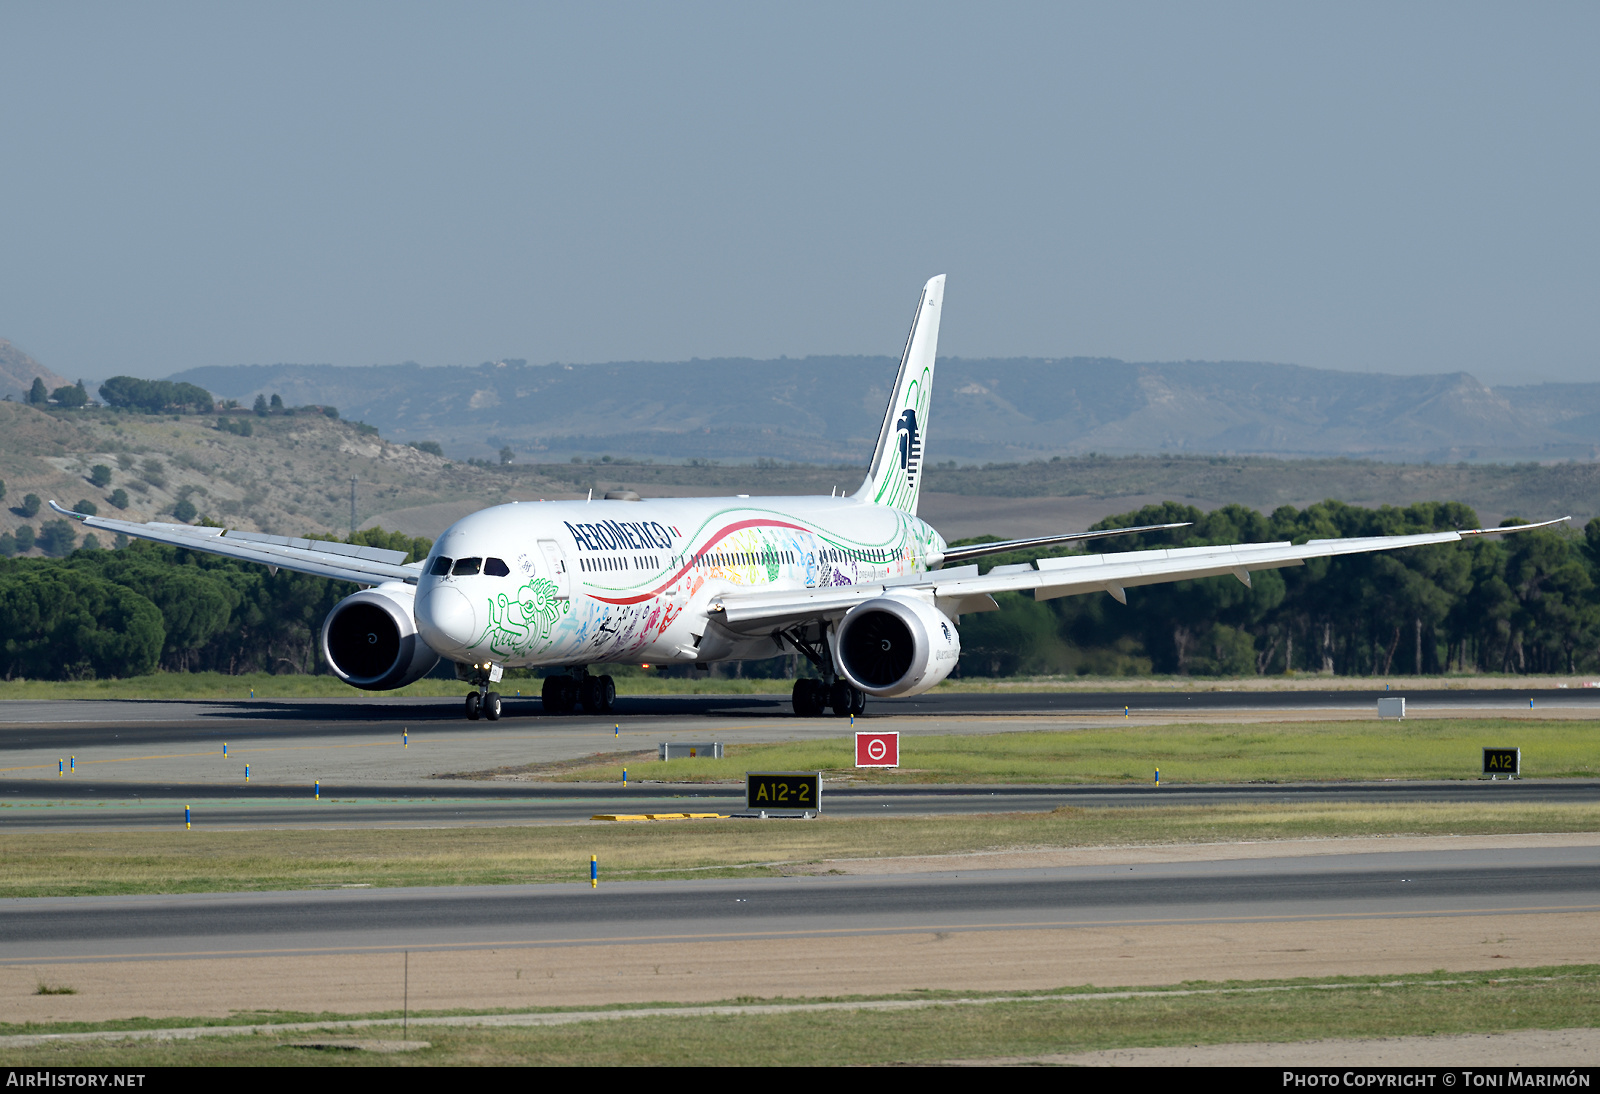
[416,497,944,667]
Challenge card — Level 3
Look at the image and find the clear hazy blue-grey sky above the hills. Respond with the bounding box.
[0,0,1600,382]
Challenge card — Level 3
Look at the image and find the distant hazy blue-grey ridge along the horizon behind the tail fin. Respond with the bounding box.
[171,357,1600,462]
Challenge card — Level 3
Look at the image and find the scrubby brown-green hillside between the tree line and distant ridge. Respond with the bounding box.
[0,401,1600,556]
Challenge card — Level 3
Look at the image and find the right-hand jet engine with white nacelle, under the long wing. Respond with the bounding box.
[834,595,962,696]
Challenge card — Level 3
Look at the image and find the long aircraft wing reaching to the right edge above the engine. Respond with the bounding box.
[712,517,1571,633]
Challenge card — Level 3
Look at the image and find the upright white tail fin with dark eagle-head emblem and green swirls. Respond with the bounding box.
[854,274,944,515]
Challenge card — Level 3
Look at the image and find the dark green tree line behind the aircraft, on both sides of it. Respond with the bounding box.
[0,502,1600,680]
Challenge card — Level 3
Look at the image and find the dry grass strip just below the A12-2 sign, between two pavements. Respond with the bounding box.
[0,800,1600,897]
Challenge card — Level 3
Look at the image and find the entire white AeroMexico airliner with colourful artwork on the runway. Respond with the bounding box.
[51,275,1565,720]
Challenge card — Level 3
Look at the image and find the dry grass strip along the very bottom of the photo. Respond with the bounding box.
[0,966,1600,1068]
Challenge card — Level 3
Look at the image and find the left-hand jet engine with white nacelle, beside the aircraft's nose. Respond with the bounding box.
[322,581,438,691]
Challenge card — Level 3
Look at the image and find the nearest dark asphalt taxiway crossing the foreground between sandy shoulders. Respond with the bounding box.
[0,846,1600,964]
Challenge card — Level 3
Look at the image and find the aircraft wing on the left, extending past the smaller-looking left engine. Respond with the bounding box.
[50,502,422,585]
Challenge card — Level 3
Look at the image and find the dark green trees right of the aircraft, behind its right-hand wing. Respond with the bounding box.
[960,501,1600,677]
